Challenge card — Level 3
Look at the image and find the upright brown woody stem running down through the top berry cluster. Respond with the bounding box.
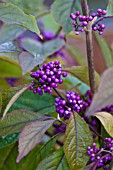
[81,0,96,96]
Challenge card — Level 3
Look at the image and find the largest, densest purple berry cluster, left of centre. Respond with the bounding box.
[30,60,67,95]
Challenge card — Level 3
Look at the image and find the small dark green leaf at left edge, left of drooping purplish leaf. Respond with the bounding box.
[0,133,19,149]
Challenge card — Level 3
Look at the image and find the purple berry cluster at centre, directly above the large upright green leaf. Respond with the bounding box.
[55,92,84,119]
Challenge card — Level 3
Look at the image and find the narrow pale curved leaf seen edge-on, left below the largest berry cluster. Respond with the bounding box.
[3,87,28,118]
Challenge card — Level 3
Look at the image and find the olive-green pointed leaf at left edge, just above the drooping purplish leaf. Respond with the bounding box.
[0,109,47,135]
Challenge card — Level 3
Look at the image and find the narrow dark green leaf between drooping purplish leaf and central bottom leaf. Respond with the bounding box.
[36,134,59,165]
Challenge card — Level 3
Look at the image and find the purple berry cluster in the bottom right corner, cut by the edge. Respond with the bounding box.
[87,138,113,170]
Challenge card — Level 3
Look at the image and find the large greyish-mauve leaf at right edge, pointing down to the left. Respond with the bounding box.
[86,67,113,116]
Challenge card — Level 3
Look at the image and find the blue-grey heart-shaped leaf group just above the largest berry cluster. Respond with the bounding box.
[19,38,64,74]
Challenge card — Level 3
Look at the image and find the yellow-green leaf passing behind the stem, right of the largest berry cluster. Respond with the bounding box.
[64,66,99,86]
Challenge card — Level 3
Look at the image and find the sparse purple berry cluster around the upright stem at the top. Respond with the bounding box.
[70,9,106,35]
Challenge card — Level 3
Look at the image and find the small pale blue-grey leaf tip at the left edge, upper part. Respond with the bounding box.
[0,42,20,53]
